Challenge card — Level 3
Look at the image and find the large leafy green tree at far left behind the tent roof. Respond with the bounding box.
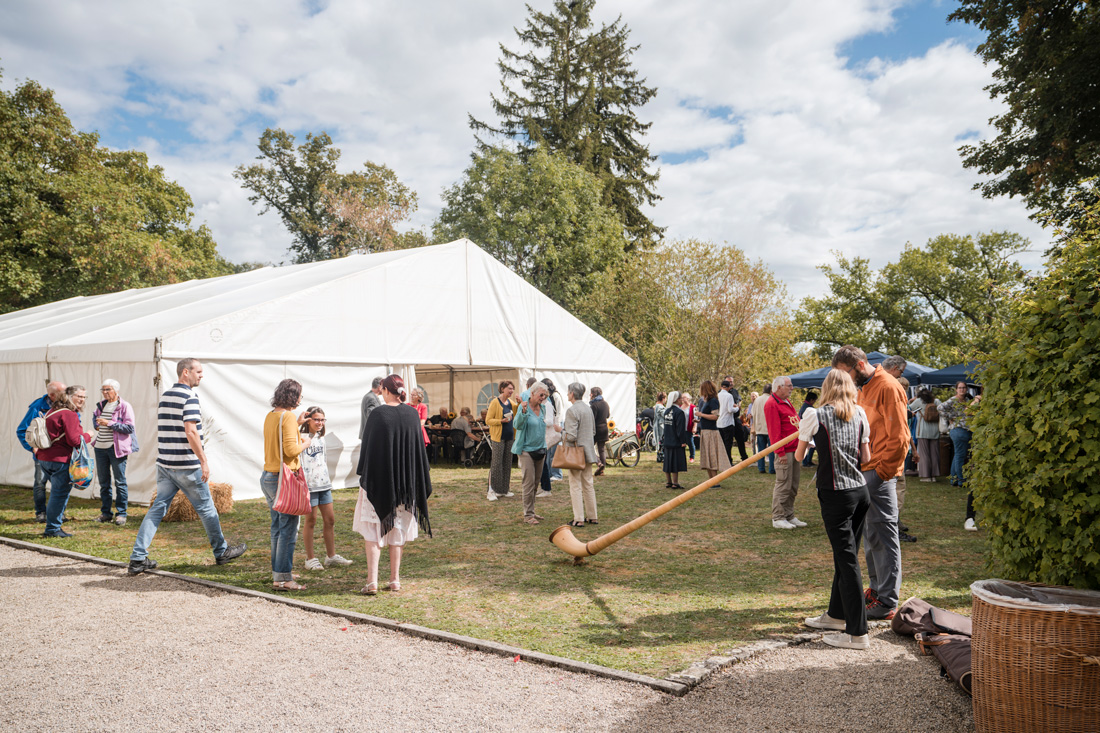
[0,75,231,313]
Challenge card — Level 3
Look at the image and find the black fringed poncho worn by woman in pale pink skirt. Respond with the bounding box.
[359,405,431,537]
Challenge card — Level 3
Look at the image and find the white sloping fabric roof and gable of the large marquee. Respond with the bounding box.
[0,240,635,373]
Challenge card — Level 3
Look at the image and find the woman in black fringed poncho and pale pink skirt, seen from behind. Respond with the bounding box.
[352,374,431,595]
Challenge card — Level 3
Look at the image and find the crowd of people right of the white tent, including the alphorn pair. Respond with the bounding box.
[642,346,980,649]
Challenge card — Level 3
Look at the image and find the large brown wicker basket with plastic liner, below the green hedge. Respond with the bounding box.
[970,580,1100,733]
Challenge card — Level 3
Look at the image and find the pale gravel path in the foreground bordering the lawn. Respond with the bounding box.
[0,545,974,733]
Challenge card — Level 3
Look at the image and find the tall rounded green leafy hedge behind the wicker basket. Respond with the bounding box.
[968,189,1100,589]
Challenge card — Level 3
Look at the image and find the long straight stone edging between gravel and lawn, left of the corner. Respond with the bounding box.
[0,536,694,697]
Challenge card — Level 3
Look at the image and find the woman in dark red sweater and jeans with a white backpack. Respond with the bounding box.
[34,384,94,537]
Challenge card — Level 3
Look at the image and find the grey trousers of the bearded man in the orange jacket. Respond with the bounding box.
[864,471,901,609]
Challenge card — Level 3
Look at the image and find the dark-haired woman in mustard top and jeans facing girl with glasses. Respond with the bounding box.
[260,380,310,591]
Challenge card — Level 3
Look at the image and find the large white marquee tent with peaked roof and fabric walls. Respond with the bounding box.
[0,240,635,503]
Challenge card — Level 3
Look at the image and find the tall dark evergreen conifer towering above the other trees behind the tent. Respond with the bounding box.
[470,0,663,247]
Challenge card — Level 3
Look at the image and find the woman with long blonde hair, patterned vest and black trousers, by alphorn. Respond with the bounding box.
[794,369,871,649]
